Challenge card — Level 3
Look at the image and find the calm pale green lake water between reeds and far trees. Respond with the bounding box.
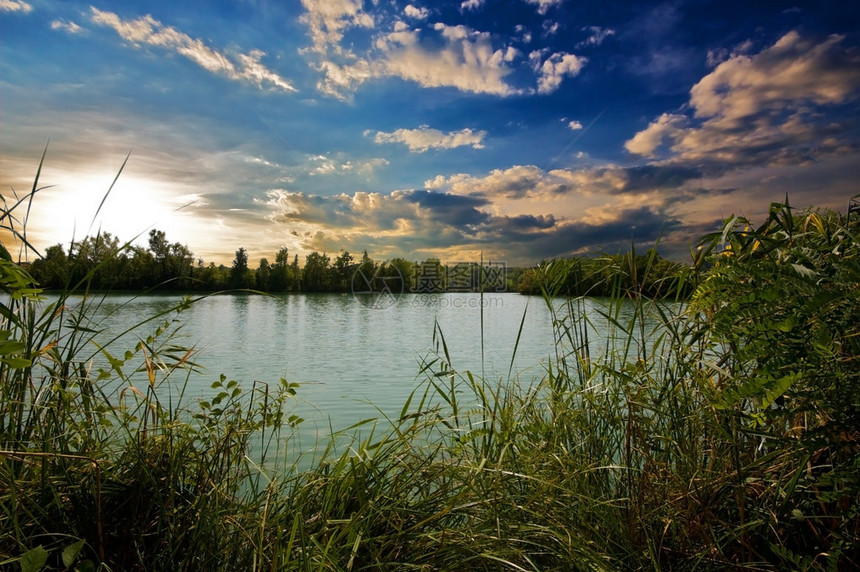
[48,293,652,454]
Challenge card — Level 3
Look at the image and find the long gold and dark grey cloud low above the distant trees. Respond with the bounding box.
[260,184,679,264]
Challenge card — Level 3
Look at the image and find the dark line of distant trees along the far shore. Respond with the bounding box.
[30,230,690,297]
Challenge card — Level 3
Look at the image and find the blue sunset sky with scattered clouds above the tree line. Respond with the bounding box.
[0,0,860,266]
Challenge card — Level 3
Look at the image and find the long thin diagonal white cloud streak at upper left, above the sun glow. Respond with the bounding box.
[90,6,296,91]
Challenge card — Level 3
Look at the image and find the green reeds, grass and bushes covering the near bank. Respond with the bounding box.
[0,158,860,571]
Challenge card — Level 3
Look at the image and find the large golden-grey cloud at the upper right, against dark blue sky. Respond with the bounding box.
[625,32,860,166]
